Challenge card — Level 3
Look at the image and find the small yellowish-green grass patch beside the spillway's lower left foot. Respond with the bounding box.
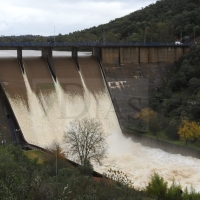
[24,150,45,164]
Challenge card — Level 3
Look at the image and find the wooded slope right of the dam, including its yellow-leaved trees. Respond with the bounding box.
[133,45,200,148]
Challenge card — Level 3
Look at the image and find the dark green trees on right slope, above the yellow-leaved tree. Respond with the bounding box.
[152,45,200,120]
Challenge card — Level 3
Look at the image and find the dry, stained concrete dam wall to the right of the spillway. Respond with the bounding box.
[93,46,189,129]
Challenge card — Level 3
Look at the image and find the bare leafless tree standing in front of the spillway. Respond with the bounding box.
[64,118,107,166]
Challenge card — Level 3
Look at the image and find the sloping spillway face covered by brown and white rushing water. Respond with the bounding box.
[0,52,120,148]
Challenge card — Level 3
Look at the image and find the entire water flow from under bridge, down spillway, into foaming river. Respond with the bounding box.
[0,51,200,192]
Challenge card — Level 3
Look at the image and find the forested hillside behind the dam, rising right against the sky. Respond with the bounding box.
[0,0,200,42]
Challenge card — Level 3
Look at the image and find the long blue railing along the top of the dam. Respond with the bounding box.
[0,42,194,48]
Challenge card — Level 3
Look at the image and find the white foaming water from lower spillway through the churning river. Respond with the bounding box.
[2,53,200,191]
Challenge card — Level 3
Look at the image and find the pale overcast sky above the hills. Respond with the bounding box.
[0,0,157,36]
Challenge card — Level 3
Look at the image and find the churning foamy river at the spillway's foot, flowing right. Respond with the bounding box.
[95,132,200,191]
